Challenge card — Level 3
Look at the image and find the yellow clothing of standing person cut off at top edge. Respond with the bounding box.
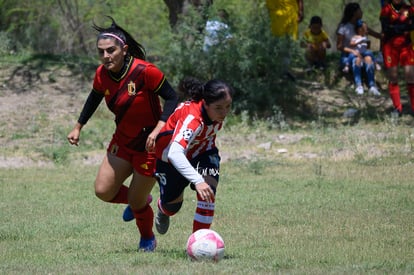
[266,0,304,40]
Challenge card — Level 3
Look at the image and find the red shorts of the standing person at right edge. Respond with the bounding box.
[382,40,414,69]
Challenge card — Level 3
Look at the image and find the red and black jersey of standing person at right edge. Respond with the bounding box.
[380,3,414,46]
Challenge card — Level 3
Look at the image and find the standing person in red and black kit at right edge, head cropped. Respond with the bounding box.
[380,0,414,115]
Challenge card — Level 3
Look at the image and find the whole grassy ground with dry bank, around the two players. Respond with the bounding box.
[0,55,414,275]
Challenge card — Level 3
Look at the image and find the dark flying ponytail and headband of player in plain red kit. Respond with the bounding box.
[93,16,146,60]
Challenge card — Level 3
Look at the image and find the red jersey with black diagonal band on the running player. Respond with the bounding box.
[93,58,165,138]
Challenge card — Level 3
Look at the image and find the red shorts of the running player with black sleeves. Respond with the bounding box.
[107,133,155,177]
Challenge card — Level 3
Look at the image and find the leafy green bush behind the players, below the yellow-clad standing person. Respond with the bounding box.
[159,4,300,117]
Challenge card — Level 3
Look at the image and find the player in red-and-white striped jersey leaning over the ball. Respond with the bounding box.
[155,78,233,237]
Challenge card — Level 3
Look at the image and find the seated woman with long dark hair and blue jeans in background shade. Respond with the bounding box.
[336,2,379,95]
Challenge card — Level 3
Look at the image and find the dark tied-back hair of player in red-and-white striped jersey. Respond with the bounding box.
[178,77,234,105]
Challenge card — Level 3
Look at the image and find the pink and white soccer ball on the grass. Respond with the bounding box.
[187,229,224,262]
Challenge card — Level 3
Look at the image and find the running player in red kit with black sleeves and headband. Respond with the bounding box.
[67,15,178,251]
